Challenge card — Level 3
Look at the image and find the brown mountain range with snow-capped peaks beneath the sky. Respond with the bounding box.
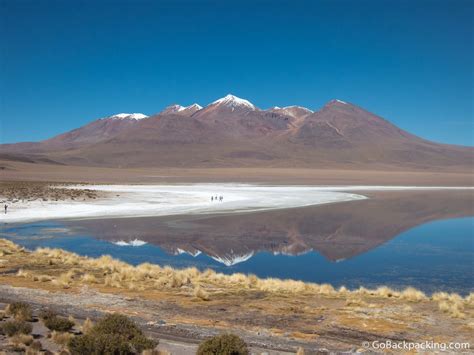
[0,95,474,170]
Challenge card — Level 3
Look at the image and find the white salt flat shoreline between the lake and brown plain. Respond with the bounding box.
[0,183,474,223]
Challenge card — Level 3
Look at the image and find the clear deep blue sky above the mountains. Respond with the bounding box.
[0,0,474,145]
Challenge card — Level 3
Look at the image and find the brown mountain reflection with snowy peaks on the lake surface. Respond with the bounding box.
[66,191,474,265]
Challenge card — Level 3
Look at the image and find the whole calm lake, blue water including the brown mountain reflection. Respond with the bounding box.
[1,191,474,294]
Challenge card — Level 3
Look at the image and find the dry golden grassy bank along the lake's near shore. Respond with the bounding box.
[0,240,474,351]
